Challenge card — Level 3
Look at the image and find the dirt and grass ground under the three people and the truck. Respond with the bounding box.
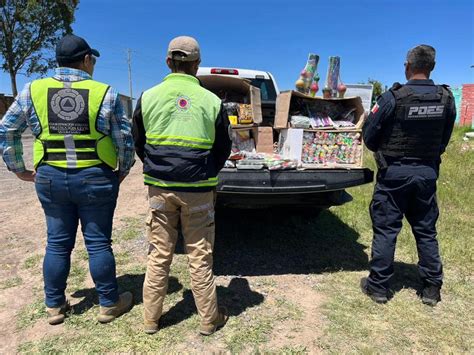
[0,130,474,354]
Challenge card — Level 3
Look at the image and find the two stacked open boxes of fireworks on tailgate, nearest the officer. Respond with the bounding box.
[274,91,365,169]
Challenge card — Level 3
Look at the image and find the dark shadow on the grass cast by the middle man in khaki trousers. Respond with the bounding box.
[160,277,264,328]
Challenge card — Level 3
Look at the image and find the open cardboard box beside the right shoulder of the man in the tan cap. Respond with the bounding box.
[199,75,262,127]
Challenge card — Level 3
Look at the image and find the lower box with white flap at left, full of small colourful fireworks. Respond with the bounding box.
[278,128,363,169]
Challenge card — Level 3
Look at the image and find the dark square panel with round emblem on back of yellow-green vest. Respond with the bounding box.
[48,88,90,134]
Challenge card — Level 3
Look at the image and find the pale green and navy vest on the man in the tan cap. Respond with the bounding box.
[141,74,221,191]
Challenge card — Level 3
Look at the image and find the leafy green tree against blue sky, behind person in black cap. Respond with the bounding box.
[0,0,79,96]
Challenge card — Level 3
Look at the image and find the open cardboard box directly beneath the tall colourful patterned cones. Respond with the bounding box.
[274,90,365,130]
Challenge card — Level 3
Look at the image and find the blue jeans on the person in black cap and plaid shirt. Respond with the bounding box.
[35,164,118,307]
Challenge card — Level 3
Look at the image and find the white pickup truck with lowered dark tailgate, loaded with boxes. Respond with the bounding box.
[197,67,374,211]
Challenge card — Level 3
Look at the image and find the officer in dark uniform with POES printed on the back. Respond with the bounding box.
[361,45,456,306]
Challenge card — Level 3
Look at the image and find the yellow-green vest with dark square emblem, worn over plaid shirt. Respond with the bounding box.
[30,78,117,169]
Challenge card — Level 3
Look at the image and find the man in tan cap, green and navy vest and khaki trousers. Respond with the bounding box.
[133,36,232,335]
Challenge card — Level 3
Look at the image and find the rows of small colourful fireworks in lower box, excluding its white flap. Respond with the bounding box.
[301,130,363,168]
